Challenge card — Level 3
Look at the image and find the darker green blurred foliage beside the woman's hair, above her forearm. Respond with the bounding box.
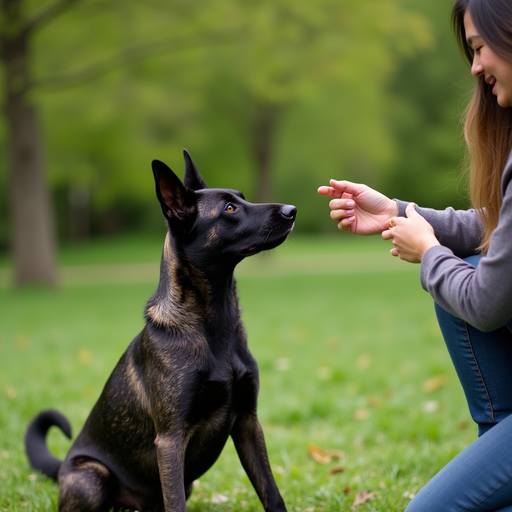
[383,0,474,208]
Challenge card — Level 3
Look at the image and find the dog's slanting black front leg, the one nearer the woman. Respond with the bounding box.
[231,412,286,512]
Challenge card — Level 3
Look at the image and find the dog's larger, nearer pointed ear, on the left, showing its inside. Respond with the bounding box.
[151,160,195,220]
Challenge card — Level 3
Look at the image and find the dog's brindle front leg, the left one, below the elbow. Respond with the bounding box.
[155,434,187,512]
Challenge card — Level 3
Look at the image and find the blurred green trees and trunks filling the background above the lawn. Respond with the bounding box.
[0,0,472,284]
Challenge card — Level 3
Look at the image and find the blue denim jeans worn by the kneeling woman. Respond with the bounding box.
[407,256,512,512]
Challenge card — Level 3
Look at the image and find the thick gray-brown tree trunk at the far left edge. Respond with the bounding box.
[0,0,57,286]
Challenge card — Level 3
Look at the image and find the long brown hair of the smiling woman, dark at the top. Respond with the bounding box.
[452,0,512,252]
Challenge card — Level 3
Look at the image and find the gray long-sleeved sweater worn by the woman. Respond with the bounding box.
[397,149,512,331]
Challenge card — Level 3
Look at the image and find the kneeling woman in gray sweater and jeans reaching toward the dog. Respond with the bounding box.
[319,0,512,512]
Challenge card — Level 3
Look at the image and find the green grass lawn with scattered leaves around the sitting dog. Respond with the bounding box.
[0,235,476,512]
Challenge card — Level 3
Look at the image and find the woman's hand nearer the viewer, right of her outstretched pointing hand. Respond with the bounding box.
[382,203,441,263]
